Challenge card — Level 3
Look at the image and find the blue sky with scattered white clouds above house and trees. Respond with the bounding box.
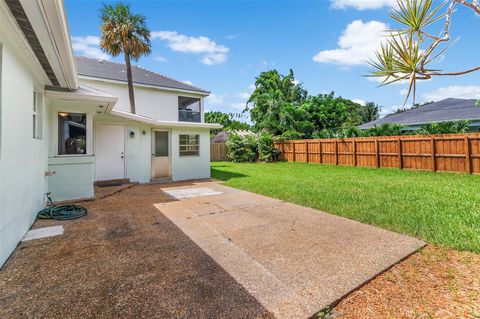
[66,0,480,119]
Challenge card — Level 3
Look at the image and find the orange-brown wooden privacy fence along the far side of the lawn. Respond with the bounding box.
[275,133,480,174]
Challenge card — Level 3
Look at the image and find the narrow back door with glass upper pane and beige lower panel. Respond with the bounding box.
[152,130,170,179]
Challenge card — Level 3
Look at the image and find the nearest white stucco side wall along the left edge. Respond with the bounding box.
[0,35,48,265]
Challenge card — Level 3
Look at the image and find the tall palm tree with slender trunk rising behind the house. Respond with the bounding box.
[100,3,150,114]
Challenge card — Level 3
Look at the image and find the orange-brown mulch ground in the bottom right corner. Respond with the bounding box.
[332,245,480,319]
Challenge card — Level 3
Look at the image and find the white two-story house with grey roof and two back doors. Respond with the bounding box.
[0,0,221,266]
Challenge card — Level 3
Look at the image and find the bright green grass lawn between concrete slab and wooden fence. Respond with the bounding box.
[211,162,480,253]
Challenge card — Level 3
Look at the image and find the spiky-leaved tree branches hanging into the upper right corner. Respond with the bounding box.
[370,0,480,104]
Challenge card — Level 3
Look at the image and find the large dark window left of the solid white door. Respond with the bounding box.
[58,112,87,155]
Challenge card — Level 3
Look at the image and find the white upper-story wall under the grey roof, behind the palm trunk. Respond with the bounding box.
[80,78,204,123]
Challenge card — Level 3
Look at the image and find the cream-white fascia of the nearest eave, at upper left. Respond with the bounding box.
[39,0,78,90]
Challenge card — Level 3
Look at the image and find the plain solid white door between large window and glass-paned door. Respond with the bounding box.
[95,124,125,181]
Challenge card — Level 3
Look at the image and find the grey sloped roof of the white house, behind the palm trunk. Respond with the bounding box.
[75,56,210,94]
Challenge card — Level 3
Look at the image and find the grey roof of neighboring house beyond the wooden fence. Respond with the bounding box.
[358,98,480,129]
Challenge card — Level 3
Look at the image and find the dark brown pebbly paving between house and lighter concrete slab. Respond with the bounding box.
[0,185,271,319]
